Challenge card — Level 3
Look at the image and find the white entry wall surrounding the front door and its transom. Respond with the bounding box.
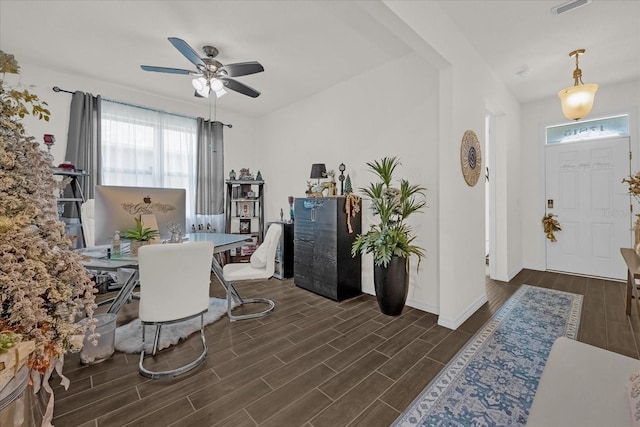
[521,80,640,270]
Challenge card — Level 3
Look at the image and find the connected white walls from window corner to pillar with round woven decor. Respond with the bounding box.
[8,1,528,328]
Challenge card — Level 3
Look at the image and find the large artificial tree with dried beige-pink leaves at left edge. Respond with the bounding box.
[0,51,97,423]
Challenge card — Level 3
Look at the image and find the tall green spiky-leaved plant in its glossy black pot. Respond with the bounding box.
[351,157,426,316]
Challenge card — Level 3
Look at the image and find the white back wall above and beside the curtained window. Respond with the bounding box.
[5,58,255,179]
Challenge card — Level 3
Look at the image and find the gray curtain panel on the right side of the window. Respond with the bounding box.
[196,117,224,215]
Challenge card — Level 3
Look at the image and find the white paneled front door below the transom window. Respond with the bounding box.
[545,137,632,279]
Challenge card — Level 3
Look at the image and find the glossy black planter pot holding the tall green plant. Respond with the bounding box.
[373,257,409,316]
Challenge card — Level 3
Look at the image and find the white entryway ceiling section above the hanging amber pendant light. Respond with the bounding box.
[439,0,640,103]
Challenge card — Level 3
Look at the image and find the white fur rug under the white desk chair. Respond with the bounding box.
[115,298,235,353]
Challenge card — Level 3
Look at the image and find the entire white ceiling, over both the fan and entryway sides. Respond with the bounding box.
[0,0,640,116]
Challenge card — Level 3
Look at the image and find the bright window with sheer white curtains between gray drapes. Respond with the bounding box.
[101,100,198,232]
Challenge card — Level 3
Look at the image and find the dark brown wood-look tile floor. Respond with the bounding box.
[51,270,640,427]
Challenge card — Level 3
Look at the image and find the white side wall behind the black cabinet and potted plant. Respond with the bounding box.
[256,54,439,312]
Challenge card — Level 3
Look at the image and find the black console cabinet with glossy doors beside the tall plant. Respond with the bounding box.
[293,196,362,301]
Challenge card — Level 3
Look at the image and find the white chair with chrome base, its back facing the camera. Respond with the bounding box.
[138,242,213,378]
